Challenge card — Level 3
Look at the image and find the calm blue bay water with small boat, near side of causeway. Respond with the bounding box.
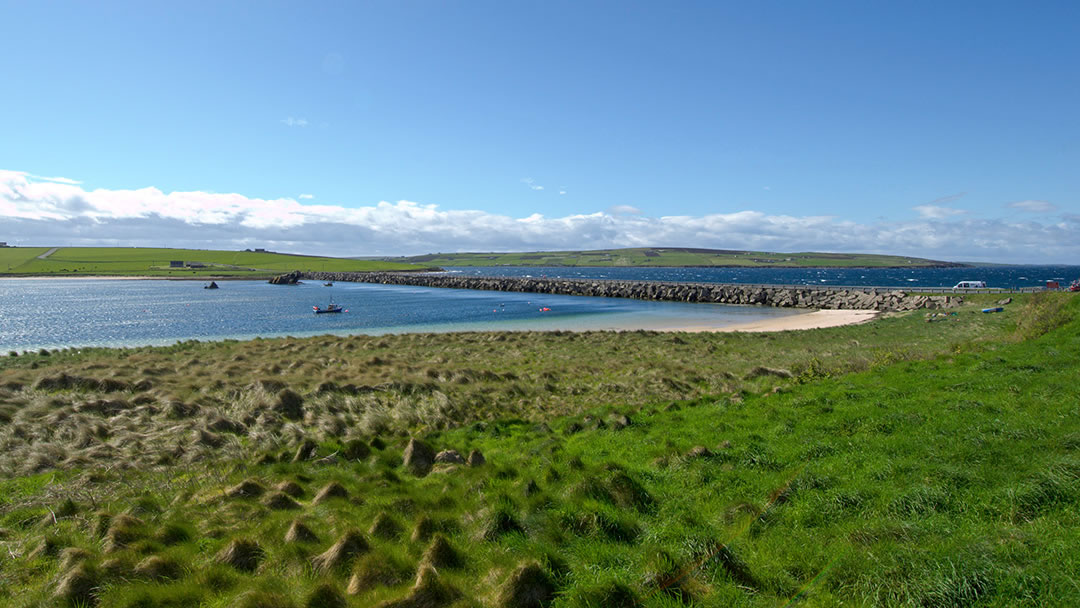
[0,279,797,351]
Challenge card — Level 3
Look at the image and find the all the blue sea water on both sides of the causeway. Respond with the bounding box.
[0,266,1080,352]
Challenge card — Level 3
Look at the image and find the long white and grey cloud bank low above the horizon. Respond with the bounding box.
[0,170,1080,264]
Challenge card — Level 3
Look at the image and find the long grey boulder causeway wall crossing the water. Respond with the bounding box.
[270,272,963,311]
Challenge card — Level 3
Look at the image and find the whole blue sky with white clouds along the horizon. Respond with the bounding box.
[0,0,1080,264]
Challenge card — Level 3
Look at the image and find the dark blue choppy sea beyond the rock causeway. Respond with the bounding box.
[442,266,1080,288]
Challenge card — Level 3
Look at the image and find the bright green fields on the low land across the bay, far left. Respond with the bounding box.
[0,247,426,276]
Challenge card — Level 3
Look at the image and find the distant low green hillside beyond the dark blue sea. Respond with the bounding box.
[381,247,967,268]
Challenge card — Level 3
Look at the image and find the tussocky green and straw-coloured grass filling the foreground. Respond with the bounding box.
[0,294,1080,607]
